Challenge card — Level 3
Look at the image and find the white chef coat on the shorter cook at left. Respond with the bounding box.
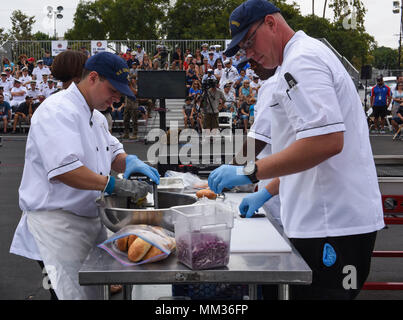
[19,83,124,217]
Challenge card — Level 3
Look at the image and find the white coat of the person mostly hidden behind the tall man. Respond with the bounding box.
[248,68,282,225]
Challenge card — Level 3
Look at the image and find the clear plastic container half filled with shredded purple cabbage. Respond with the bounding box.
[172,201,234,270]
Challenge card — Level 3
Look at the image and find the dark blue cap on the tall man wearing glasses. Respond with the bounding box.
[224,0,280,57]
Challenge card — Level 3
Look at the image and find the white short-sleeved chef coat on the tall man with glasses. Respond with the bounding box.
[270,31,384,238]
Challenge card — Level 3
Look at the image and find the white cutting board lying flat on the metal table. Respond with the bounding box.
[230,218,291,253]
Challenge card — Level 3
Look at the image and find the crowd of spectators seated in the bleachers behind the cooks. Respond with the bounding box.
[0,44,261,136]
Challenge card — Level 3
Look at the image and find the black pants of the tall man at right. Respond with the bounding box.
[262,232,377,300]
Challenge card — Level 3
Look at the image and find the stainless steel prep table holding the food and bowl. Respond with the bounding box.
[79,201,312,300]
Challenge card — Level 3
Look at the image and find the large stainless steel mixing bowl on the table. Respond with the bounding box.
[96,191,197,232]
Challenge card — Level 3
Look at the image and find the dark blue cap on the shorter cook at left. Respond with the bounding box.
[84,52,135,98]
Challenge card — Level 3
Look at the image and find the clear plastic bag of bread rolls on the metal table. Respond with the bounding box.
[98,224,176,266]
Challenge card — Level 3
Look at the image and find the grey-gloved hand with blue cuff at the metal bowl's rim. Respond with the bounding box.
[104,176,153,201]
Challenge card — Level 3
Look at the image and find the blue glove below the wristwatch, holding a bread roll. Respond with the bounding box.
[208,164,252,194]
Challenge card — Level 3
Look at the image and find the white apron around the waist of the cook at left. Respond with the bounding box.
[27,210,106,300]
